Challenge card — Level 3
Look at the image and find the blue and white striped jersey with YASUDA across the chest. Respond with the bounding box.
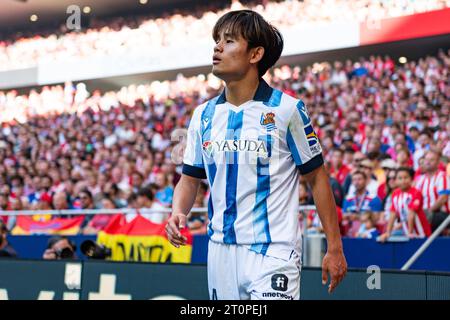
[183,80,323,259]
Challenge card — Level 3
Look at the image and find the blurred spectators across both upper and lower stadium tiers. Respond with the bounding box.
[0,0,450,245]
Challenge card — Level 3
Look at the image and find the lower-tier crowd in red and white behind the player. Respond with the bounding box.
[0,47,450,240]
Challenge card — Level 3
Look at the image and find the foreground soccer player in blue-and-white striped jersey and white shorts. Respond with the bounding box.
[166,10,347,300]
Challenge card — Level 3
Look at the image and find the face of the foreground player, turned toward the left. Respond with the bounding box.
[212,31,251,82]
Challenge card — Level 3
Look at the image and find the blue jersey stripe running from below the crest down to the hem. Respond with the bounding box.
[251,135,272,254]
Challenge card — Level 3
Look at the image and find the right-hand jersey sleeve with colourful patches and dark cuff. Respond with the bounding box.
[286,100,323,174]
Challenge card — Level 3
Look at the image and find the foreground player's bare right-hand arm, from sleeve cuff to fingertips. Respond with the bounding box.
[304,165,347,293]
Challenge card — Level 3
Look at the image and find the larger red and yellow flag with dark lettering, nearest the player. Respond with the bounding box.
[97,215,192,263]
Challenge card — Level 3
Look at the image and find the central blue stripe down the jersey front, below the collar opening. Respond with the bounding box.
[223,110,244,244]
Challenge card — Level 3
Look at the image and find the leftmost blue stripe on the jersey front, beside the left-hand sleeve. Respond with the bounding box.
[200,97,219,237]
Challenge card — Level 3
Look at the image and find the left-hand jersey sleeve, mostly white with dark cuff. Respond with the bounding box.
[183,107,206,179]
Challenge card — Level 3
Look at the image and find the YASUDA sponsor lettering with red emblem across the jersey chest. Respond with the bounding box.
[203,139,268,157]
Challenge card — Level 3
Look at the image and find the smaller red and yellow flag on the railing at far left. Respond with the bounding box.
[11,216,84,236]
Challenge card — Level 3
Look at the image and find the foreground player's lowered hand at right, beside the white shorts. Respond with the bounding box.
[322,250,347,293]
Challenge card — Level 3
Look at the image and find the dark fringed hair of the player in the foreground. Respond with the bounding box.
[212,10,284,78]
